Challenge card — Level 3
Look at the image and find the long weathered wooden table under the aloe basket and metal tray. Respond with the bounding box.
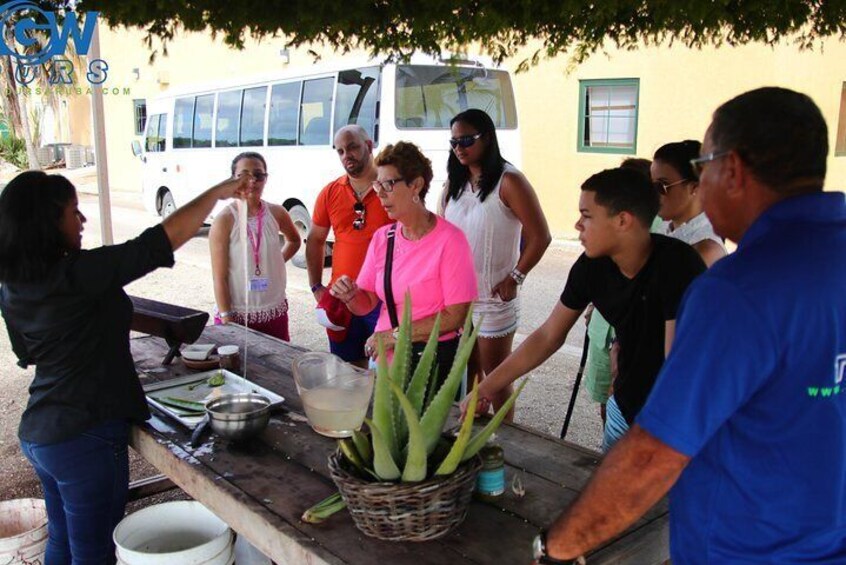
[131,326,669,565]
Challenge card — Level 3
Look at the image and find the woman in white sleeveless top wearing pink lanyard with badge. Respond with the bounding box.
[209,151,300,341]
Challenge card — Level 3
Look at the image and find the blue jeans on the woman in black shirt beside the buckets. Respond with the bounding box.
[21,421,129,565]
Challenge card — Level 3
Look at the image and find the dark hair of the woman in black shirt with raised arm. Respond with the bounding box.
[0,167,76,283]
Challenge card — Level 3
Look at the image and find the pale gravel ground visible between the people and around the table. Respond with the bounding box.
[0,171,601,504]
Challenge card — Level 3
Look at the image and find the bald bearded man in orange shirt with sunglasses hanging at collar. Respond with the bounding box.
[306,125,391,367]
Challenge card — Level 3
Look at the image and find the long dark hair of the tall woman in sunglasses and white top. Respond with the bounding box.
[447,108,506,202]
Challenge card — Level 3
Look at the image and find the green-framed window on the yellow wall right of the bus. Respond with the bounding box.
[578,78,640,155]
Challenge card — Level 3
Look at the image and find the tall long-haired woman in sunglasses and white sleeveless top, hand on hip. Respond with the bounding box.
[441,109,552,416]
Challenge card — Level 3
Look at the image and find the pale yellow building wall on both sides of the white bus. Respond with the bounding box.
[83,28,846,237]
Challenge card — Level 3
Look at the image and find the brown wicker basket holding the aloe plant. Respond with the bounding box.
[329,452,481,541]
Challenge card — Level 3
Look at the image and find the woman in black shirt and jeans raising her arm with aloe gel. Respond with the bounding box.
[0,171,247,565]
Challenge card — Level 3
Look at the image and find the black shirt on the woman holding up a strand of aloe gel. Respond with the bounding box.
[0,225,173,443]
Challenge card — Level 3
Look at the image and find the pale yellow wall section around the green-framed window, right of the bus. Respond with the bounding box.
[514,41,846,237]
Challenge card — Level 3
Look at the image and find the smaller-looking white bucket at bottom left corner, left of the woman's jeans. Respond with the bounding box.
[0,498,47,565]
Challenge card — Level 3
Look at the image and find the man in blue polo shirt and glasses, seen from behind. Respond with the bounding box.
[538,88,846,565]
